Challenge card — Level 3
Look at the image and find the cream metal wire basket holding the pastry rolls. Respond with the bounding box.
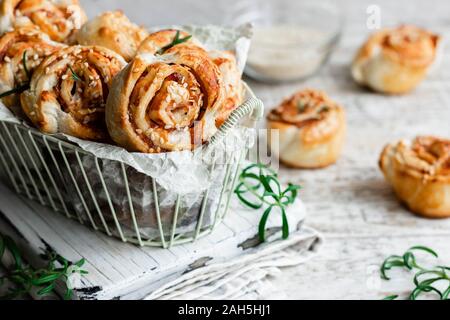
[0,85,264,248]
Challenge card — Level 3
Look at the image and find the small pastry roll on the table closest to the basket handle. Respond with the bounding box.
[267,89,346,168]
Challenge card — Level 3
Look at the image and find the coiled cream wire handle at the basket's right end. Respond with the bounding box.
[205,92,264,150]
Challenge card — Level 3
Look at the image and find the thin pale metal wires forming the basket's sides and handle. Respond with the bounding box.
[0,91,263,248]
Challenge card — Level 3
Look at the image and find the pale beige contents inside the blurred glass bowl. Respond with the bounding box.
[247,25,330,81]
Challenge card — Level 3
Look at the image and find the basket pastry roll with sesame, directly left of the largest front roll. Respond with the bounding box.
[20,46,126,140]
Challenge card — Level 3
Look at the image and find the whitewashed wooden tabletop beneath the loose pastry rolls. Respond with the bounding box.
[6,0,450,299]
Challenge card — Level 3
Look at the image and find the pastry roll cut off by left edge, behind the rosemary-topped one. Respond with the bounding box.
[0,27,64,112]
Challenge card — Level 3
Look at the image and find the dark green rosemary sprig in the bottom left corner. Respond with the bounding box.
[0,234,87,300]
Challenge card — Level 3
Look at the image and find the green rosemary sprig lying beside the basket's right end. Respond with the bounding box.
[234,164,301,241]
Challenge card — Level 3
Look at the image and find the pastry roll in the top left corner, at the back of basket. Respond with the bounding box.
[0,0,87,42]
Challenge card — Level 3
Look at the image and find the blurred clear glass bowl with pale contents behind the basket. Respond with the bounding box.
[225,0,343,82]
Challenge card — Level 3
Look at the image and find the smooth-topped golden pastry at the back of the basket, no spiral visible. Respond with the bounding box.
[75,11,148,61]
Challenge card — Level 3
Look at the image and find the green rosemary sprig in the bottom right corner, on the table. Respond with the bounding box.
[380,246,450,300]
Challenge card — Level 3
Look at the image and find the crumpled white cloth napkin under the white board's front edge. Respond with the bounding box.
[146,227,322,300]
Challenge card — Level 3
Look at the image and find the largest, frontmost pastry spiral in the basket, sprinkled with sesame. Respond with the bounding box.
[106,43,224,153]
